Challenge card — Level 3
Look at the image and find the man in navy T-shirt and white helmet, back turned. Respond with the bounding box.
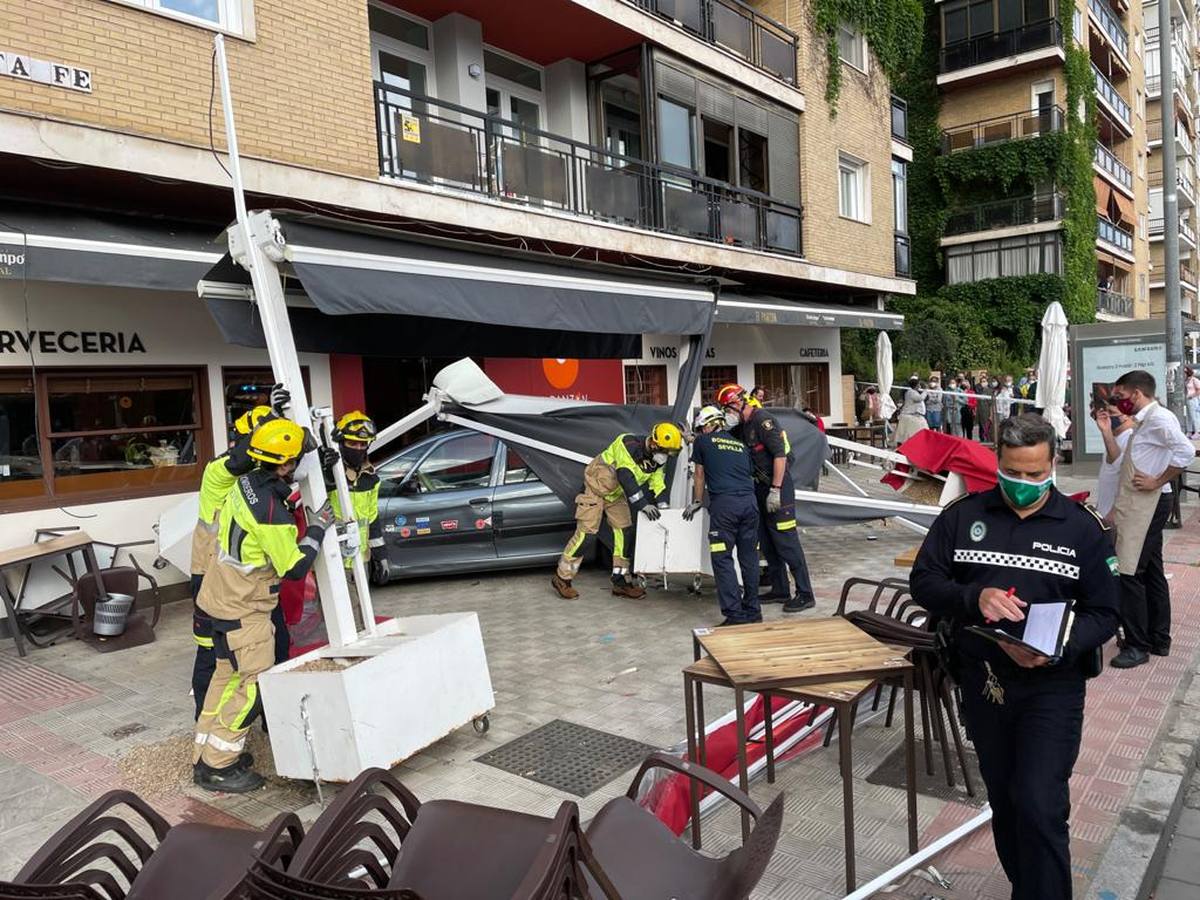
[683,407,762,625]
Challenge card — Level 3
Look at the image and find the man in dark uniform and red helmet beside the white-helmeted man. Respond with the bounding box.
[716,384,816,613]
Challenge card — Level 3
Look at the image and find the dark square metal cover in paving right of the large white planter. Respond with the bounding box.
[478,719,655,797]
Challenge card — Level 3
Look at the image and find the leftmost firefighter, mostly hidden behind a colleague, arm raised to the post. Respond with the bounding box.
[192,398,283,719]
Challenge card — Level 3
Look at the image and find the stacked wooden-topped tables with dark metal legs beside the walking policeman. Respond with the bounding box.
[683,618,917,893]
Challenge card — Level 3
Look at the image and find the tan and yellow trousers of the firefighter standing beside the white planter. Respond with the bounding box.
[193,612,275,769]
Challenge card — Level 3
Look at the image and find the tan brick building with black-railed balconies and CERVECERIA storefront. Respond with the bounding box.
[0,0,914,585]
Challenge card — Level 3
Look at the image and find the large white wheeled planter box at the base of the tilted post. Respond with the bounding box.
[259,612,496,781]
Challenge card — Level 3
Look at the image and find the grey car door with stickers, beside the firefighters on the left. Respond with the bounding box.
[379,431,498,575]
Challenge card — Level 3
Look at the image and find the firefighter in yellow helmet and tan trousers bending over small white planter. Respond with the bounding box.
[550,422,683,600]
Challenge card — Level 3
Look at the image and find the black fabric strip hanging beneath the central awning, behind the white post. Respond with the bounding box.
[204,299,642,359]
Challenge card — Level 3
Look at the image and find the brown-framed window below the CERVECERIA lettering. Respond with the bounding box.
[0,368,212,506]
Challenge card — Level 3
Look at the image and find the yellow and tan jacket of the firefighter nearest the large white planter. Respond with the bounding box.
[197,468,323,619]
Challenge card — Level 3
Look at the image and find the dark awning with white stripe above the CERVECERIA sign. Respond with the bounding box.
[0,204,224,293]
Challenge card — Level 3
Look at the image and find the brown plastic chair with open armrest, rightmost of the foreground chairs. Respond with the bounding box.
[584,752,784,900]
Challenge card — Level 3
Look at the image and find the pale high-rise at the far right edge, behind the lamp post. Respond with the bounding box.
[1142,0,1200,320]
